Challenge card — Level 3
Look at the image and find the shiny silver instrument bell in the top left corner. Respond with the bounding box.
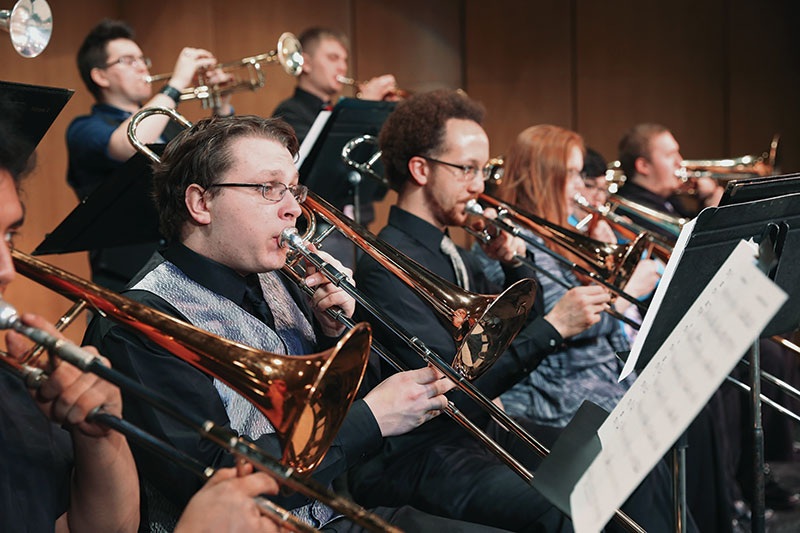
[0,0,53,57]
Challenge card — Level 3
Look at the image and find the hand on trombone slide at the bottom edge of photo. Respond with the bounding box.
[175,464,281,533]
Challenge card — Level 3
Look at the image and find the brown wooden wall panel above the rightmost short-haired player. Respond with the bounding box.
[574,0,727,159]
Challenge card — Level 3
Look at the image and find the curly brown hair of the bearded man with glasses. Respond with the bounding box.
[378,89,486,191]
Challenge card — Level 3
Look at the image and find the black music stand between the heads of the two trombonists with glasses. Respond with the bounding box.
[300,98,395,213]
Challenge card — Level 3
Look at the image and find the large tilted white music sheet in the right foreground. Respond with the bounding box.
[570,241,787,533]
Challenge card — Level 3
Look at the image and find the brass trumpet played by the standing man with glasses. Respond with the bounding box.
[145,32,303,109]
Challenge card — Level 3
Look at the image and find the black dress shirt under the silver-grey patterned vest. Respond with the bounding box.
[85,245,382,509]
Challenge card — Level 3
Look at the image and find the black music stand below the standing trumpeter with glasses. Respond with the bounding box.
[33,144,164,255]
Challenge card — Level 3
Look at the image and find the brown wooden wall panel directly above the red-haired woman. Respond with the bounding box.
[465,0,572,154]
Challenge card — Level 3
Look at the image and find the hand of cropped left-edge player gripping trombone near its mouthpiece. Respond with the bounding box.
[6,313,122,437]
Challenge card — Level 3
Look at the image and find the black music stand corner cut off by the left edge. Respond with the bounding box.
[0,81,75,156]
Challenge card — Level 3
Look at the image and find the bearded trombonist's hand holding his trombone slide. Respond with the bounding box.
[544,285,611,339]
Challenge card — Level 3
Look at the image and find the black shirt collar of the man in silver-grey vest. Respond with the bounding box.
[163,243,247,306]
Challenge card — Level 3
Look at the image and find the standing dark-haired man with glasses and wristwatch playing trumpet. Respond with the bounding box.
[67,19,233,291]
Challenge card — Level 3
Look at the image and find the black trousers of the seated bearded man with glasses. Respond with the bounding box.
[349,420,693,533]
